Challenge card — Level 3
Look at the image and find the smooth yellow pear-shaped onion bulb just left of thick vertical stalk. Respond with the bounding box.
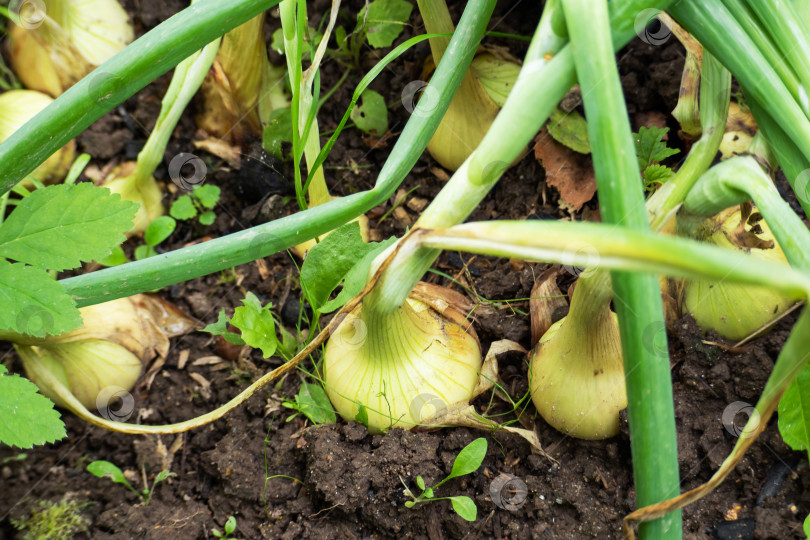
[529,272,627,440]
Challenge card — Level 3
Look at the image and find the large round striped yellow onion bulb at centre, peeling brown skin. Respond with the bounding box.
[323,284,482,432]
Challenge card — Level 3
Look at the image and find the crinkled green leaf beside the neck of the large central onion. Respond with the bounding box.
[301,221,394,313]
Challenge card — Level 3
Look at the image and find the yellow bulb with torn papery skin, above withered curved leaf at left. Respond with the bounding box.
[15,339,143,409]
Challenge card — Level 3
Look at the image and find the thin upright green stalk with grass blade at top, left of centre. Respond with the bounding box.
[279,0,368,257]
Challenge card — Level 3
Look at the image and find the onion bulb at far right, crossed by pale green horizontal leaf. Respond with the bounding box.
[681,206,795,340]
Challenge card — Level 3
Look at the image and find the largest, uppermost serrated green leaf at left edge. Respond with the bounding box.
[0,183,138,270]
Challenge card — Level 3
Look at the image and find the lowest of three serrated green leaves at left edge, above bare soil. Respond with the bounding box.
[0,364,67,448]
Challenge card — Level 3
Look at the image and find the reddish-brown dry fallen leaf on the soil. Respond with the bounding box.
[534,127,596,211]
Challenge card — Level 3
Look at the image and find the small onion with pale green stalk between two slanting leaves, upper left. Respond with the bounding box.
[102,23,220,235]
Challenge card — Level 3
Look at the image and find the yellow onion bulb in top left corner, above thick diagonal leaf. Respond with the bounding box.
[9,0,134,97]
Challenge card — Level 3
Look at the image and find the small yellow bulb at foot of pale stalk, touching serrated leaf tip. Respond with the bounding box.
[101,161,165,236]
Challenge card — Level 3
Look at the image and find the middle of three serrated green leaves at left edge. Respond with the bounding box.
[0,260,82,337]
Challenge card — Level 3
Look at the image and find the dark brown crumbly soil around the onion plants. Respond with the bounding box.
[0,0,810,540]
